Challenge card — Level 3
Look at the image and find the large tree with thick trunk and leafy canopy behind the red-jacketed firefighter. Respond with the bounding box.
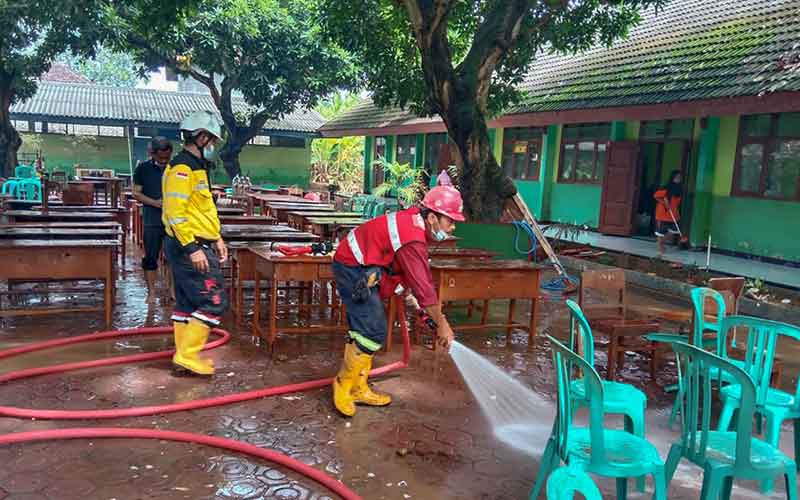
[316,0,665,220]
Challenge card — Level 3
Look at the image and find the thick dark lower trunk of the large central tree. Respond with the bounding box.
[442,98,517,222]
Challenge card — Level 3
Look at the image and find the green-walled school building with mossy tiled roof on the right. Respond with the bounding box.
[320,0,800,262]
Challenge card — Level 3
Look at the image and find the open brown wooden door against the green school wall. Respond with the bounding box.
[599,141,640,236]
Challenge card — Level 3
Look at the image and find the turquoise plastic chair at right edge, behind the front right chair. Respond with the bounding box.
[718,316,800,493]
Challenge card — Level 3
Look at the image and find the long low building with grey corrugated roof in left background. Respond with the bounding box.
[11,81,325,187]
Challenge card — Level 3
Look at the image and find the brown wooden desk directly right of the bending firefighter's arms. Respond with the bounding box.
[412,258,541,346]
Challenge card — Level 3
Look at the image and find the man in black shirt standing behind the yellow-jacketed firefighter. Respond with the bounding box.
[133,137,172,300]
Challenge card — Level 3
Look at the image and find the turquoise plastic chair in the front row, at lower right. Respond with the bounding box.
[667,342,797,500]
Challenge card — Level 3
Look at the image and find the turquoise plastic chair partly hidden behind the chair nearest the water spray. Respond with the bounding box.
[567,299,647,491]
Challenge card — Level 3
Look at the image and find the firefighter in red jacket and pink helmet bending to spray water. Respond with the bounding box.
[333,186,464,417]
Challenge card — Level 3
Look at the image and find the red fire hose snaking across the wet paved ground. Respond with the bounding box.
[0,301,411,500]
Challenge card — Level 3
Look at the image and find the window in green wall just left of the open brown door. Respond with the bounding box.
[558,123,611,184]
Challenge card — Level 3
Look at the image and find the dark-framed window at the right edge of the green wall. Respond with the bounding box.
[731,113,800,201]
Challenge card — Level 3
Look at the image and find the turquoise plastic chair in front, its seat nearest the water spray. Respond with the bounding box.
[530,335,667,500]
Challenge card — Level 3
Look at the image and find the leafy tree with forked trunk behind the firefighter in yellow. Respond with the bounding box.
[109,0,356,180]
